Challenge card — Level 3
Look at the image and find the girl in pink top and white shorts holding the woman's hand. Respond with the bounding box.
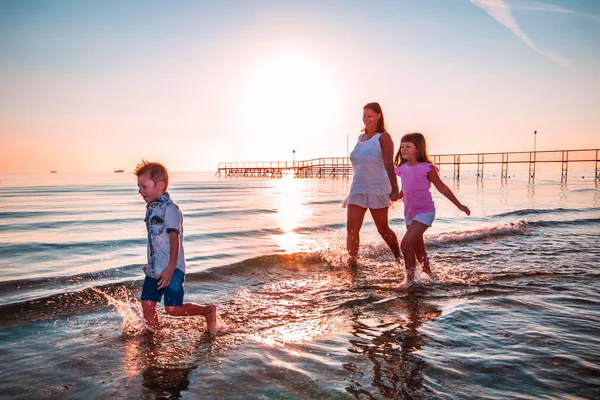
[394,133,471,290]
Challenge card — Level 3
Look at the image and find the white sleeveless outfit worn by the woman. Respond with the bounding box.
[344,132,392,208]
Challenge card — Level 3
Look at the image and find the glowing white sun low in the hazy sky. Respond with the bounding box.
[240,53,340,158]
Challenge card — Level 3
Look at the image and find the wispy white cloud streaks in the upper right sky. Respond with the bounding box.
[470,0,572,67]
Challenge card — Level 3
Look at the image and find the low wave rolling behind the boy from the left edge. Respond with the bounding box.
[0,253,329,328]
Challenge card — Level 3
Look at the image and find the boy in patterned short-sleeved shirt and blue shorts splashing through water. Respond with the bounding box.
[133,160,217,335]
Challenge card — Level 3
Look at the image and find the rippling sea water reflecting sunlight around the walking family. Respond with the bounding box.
[0,167,600,400]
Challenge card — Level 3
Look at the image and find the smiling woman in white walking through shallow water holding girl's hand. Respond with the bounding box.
[344,103,401,266]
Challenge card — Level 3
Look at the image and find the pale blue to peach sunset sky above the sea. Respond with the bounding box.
[0,0,600,173]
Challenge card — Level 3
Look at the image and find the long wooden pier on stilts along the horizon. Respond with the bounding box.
[215,149,600,181]
